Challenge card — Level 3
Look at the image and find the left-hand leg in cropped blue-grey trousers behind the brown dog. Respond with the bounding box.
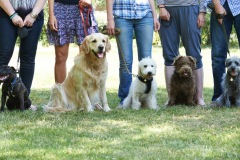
[159,7,180,103]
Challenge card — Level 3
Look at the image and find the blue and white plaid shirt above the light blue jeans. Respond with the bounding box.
[113,0,152,19]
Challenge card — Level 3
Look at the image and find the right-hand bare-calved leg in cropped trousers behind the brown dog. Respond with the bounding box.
[179,6,205,106]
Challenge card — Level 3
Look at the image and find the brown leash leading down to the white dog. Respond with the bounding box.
[102,26,138,77]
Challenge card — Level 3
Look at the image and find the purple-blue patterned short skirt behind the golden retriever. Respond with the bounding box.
[47,2,98,46]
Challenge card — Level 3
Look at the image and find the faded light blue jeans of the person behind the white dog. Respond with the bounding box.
[114,12,153,103]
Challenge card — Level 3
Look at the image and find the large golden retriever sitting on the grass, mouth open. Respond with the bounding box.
[43,33,111,112]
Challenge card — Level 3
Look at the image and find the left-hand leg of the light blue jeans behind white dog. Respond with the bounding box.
[114,17,133,103]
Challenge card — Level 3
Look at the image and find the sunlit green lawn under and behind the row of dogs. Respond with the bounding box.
[0,40,240,160]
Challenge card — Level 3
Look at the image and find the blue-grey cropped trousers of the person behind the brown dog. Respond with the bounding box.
[159,6,202,69]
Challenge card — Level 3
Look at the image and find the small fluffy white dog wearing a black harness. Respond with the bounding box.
[122,57,158,110]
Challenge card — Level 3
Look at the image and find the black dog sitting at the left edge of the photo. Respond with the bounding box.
[0,65,31,111]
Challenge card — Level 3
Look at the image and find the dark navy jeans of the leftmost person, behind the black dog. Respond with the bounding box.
[0,12,44,93]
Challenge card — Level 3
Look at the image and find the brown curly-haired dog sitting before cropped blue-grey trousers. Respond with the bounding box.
[167,56,196,106]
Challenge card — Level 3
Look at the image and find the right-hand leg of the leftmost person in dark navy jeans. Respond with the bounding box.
[19,17,43,94]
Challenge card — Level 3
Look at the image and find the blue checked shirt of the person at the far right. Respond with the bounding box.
[204,0,240,16]
